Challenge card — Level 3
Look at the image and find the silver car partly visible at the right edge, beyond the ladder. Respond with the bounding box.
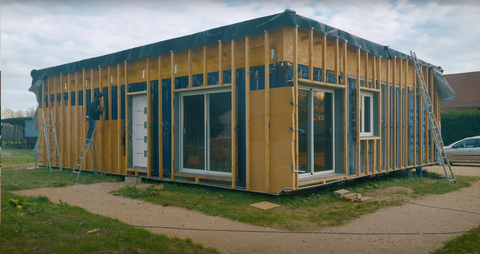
[443,136,480,164]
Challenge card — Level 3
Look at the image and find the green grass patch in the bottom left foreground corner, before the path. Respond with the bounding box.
[0,190,217,253]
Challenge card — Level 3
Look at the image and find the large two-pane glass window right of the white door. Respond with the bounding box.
[181,92,232,175]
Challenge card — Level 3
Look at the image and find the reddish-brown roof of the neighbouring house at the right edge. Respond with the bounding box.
[440,71,480,112]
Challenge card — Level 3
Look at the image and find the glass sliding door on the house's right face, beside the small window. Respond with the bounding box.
[298,89,334,176]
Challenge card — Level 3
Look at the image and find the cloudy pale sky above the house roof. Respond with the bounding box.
[0,0,480,110]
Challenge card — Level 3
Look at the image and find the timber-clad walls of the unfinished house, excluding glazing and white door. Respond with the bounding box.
[38,26,440,193]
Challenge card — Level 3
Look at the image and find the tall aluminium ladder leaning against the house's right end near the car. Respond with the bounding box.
[410,50,457,185]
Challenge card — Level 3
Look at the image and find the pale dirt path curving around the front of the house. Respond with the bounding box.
[15,165,480,254]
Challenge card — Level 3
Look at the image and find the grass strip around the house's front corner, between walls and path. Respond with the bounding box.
[113,172,480,231]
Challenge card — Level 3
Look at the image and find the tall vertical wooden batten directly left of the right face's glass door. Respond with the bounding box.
[293,25,298,189]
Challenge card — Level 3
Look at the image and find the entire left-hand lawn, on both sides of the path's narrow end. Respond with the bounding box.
[0,148,217,253]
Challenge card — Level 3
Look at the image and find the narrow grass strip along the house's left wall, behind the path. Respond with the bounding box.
[2,168,124,191]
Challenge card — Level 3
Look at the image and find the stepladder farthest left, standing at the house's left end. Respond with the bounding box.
[34,109,62,172]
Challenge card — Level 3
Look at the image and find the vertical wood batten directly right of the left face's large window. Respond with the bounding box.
[231,39,237,189]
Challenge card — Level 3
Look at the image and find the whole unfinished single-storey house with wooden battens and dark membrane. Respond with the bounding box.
[30,10,453,194]
